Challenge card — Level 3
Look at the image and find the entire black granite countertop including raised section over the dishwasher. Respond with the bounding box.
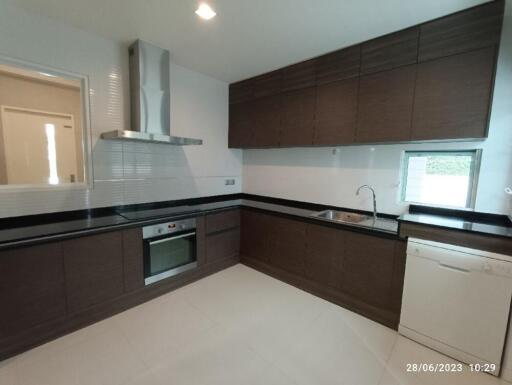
[0,194,512,248]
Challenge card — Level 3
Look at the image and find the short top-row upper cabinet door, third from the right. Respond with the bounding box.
[315,45,361,85]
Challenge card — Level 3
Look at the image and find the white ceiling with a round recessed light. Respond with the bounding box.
[9,0,486,82]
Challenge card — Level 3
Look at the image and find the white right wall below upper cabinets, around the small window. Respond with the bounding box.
[243,0,512,214]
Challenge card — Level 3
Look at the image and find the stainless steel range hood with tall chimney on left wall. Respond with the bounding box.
[101,40,203,146]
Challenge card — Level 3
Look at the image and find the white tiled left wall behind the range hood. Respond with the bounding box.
[0,3,242,217]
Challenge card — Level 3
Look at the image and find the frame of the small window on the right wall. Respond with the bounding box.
[400,148,482,210]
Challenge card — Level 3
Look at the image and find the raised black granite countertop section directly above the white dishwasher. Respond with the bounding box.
[398,205,512,238]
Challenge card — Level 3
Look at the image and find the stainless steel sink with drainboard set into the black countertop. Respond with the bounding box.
[311,210,398,234]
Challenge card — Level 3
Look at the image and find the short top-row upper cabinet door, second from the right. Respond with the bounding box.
[361,27,420,75]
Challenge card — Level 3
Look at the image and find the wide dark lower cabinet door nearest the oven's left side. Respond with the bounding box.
[62,231,124,313]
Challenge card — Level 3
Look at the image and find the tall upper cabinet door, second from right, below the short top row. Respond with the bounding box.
[356,65,416,143]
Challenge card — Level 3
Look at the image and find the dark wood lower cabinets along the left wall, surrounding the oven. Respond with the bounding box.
[0,216,239,361]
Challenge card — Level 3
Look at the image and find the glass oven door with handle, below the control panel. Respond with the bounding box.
[144,231,197,285]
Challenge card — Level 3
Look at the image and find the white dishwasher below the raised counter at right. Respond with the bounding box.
[399,238,512,375]
